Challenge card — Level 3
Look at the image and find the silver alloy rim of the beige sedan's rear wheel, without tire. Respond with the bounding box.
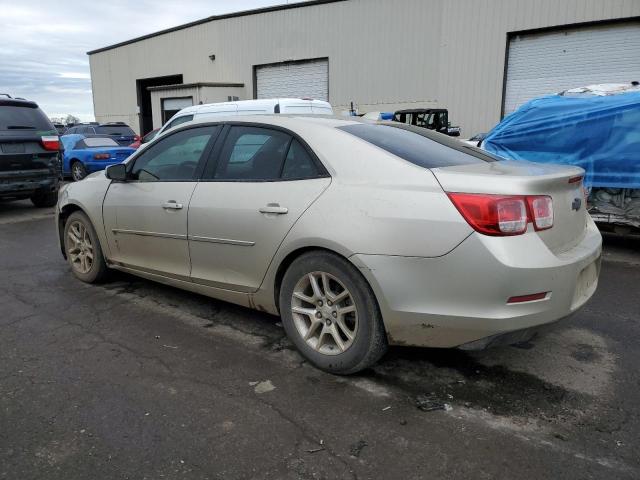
[291,272,358,355]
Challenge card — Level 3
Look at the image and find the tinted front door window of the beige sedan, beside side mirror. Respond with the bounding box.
[130,126,220,182]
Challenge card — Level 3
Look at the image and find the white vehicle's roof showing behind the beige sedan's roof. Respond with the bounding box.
[158,98,333,135]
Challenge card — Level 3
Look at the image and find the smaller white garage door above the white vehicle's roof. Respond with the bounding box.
[256,59,329,101]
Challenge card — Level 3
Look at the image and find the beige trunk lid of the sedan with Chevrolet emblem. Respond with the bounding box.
[432,160,588,254]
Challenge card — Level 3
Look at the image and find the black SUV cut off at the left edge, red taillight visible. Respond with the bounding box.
[0,94,60,207]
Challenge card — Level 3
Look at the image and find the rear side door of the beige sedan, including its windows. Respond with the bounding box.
[189,124,331,292]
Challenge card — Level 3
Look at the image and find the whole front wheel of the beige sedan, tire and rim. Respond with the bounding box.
[64,212,107,283]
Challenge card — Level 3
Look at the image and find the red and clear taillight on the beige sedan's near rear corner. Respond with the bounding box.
[447,193,553,236]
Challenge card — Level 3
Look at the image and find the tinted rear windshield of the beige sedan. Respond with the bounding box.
[338,122,500,168]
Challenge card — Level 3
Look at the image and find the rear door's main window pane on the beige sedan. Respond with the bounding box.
[213,126,292,180]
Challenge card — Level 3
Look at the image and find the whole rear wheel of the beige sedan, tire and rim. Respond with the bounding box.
[280,251,387,375]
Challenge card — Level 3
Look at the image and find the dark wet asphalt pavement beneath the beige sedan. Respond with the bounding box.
[0,202,640,480]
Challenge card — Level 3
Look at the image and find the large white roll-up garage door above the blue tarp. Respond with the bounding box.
[504,23,640,115]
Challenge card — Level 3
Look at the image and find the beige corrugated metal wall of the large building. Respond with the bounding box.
[90,0,640,135]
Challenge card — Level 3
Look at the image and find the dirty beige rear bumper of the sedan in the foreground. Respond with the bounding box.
[351,219,602,349]
